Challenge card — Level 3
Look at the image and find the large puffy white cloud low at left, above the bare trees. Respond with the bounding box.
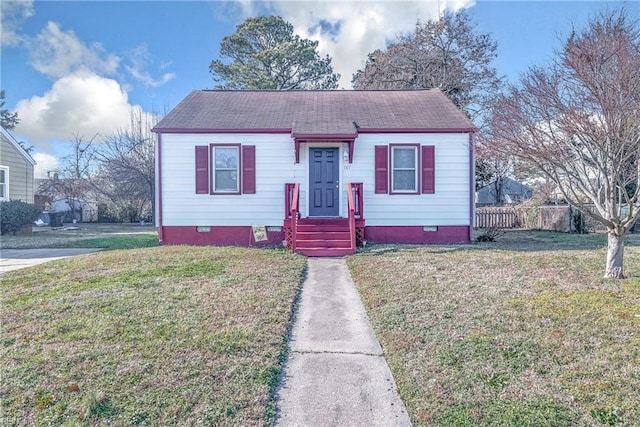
[15,70,140,148]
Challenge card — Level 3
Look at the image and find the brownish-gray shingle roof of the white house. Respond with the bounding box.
[154,89,474,136]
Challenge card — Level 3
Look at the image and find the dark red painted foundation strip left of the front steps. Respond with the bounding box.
[163,226,284,247]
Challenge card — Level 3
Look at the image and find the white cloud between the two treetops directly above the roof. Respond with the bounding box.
[258,0,475,88]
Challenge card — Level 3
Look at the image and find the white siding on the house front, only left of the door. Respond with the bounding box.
[161,134,304,226]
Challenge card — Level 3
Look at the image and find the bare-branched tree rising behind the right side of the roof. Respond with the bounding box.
[352,10,502,128]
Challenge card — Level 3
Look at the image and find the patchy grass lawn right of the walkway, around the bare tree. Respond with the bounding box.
[348,232,640,426]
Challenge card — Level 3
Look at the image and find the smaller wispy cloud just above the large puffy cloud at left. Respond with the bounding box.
[28,22,120,79]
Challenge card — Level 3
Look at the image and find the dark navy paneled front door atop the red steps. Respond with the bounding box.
[309,148,340,216]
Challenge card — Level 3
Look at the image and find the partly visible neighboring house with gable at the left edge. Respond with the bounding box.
[0,126,36,203]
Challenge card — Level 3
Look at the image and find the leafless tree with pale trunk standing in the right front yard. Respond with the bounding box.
[492,8,640,278]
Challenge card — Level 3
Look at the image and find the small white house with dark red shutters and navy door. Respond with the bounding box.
[153,89,475,256]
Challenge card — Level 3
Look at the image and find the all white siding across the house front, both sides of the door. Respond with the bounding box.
[161,134,471,226]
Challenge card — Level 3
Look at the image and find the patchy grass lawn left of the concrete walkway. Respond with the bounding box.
[0,243,305,426]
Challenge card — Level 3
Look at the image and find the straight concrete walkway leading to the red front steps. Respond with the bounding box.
[276,258,411,427]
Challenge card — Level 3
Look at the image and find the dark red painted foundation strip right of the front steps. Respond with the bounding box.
[364,225,472,245]
